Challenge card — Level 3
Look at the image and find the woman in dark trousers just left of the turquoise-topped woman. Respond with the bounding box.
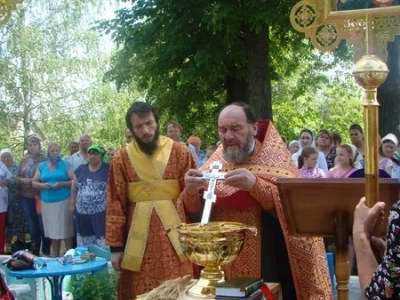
[15,134,51,256]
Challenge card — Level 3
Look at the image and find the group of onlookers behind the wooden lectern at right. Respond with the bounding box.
[288,124,400,182]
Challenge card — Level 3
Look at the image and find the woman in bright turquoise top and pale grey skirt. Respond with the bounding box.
[32,143,75,256]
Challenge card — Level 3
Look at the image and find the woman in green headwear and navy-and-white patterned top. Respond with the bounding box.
[71,145,110,249]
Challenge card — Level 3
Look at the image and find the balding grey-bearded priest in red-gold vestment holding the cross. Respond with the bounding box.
[180,103,333,300]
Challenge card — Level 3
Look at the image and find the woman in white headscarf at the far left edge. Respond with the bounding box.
[0,149,29,252]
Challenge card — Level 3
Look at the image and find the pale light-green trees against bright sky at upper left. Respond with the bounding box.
[0,0,128,157]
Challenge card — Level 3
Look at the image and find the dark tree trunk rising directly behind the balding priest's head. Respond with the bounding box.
[225,26,272,120]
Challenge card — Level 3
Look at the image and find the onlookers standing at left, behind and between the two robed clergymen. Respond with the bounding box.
[0,115,217,256]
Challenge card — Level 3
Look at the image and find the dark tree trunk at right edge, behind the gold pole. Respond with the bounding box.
[378,36,400,137]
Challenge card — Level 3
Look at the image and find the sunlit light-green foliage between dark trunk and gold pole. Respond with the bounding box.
[273,54,363,141]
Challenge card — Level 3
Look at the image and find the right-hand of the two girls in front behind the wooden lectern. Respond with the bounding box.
[328,144,357,178]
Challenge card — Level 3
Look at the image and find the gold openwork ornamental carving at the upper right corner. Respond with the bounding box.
[290,0,400,61]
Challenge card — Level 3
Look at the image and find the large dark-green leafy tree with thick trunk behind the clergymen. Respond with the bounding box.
[100,0,318,120]
